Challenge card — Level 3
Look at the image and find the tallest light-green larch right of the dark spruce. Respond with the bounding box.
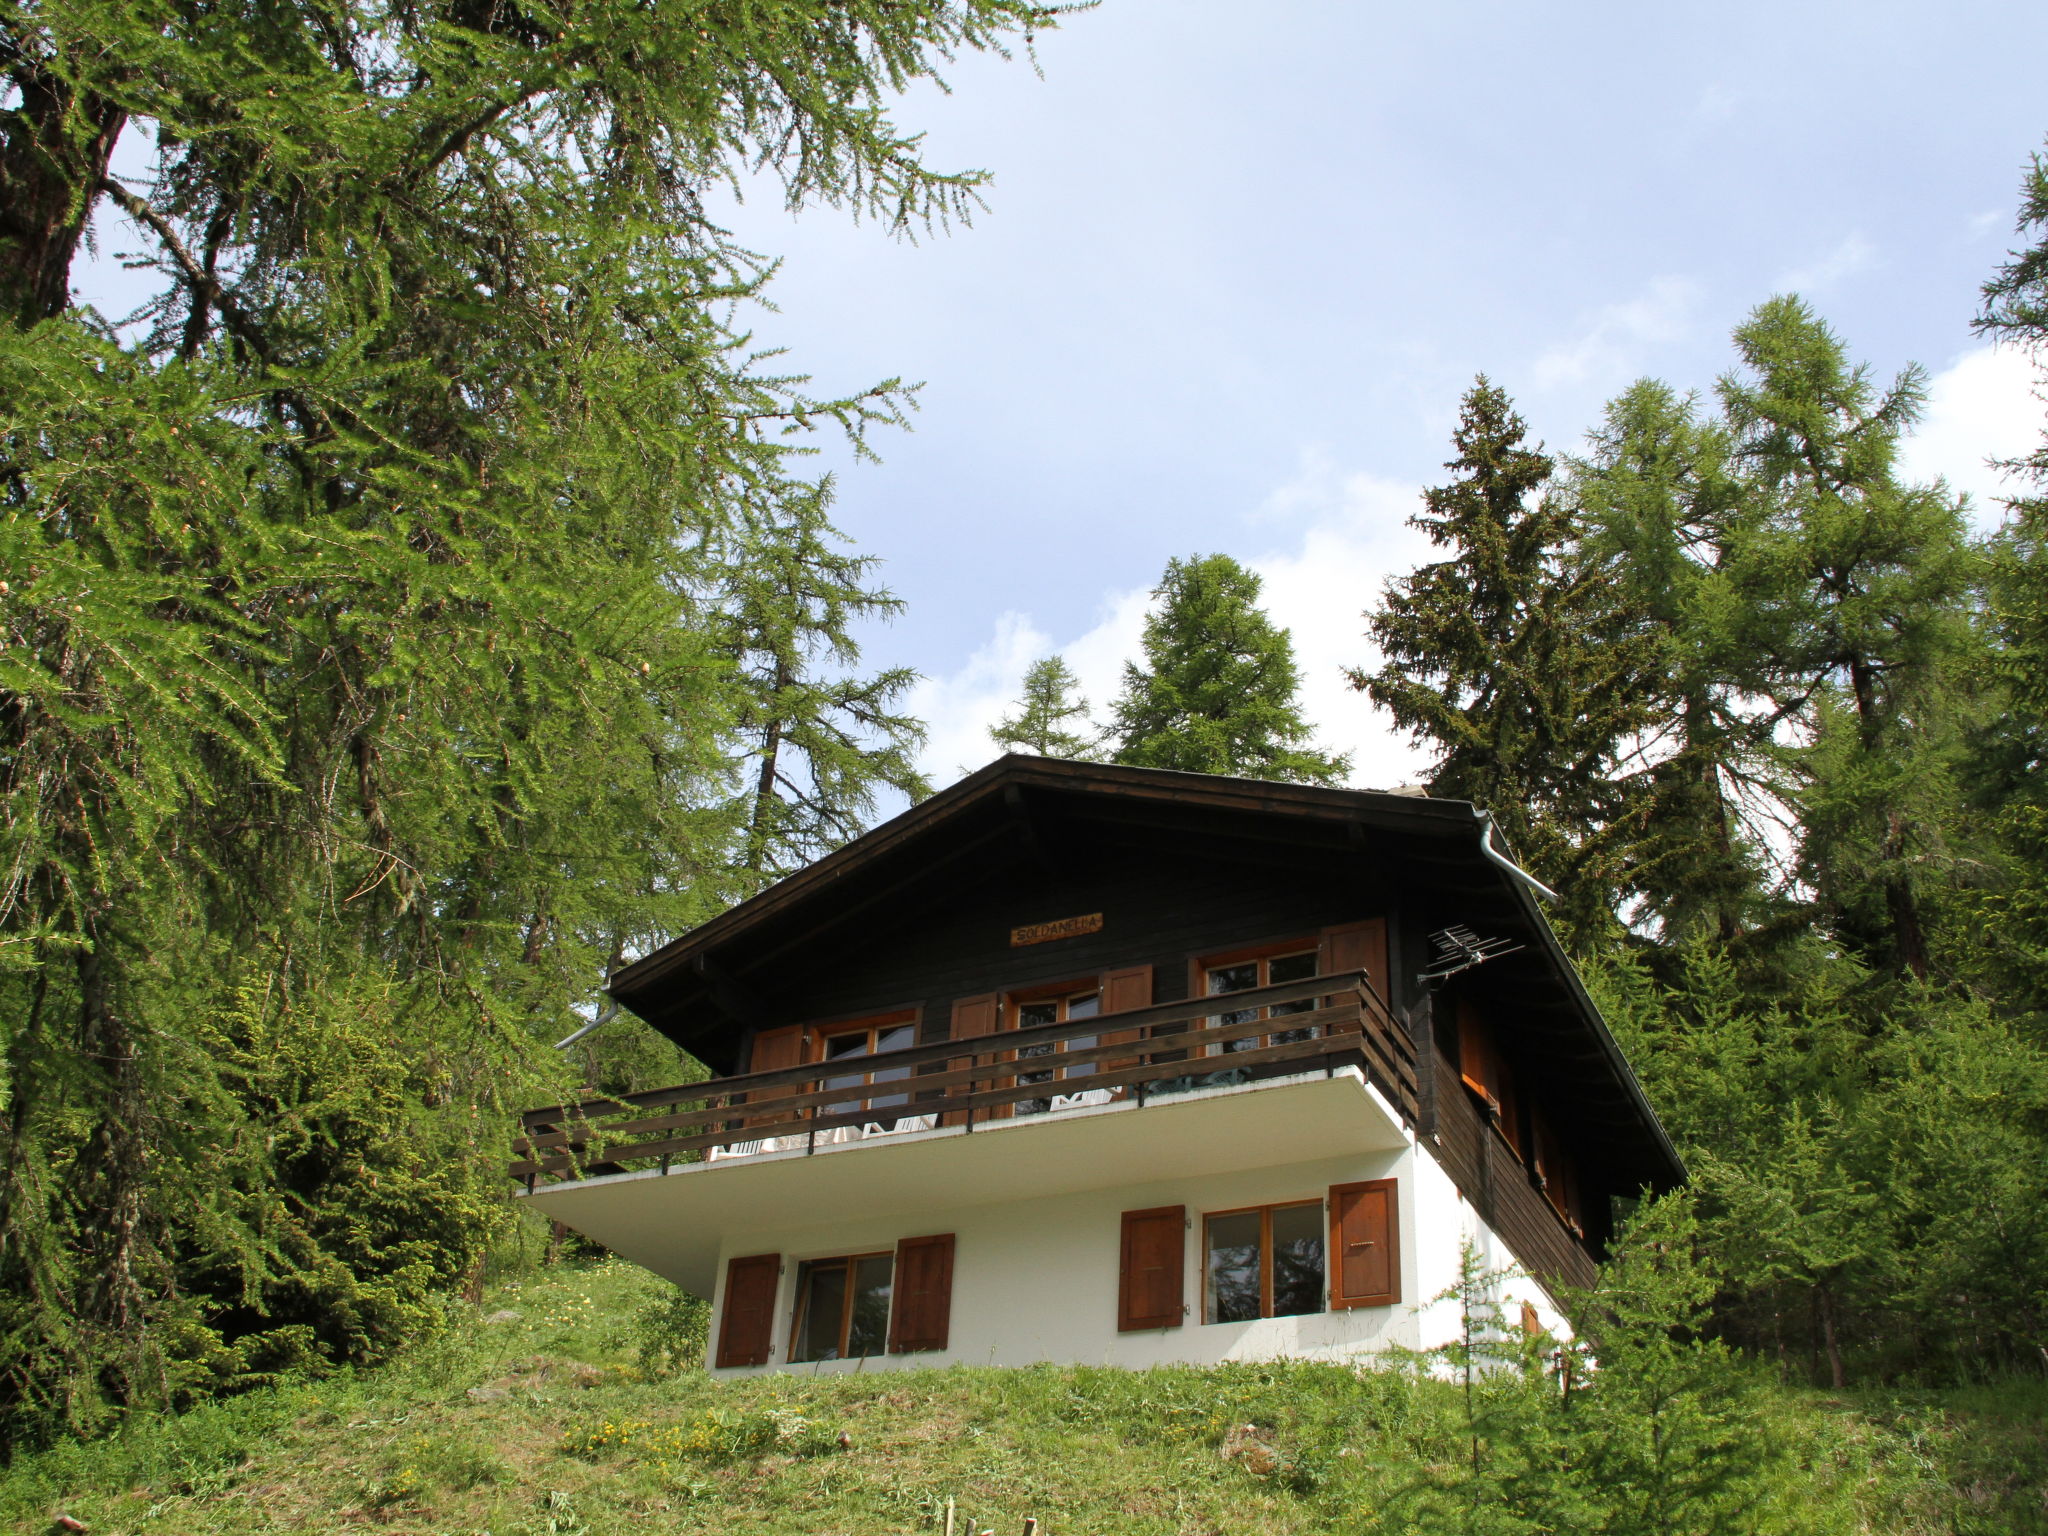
[1720,295,1978,977]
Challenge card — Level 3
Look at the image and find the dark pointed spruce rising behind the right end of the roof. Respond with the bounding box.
[1350,377,1653,926]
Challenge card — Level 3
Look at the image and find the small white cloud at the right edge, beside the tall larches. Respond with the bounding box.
[1901,346,2048,528]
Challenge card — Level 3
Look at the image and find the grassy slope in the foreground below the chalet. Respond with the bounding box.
[0,1264,2048,1536]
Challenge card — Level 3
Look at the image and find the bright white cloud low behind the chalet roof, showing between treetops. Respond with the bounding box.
[911,455,1427,788]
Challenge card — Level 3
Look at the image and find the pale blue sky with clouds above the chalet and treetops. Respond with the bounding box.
[72,0,2048,784]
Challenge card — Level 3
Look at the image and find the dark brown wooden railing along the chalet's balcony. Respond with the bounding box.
[510,971,1415,1190]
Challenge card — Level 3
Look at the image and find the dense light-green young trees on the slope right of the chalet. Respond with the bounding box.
[1593,948,2048,1389]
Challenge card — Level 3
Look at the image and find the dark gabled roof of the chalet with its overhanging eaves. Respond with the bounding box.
[610,756,1683,1186]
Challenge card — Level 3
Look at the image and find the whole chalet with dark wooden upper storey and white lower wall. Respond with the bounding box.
[512,756,1683,1372]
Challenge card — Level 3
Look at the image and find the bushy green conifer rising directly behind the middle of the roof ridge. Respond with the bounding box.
[1114,555,1350,784]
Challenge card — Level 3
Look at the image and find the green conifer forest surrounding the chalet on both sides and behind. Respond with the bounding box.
[0,0,2048,1490]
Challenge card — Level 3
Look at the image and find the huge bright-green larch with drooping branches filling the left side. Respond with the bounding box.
[0,0,1059,1436]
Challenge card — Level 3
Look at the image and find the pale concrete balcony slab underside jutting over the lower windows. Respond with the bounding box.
[520,1067,1409,1296]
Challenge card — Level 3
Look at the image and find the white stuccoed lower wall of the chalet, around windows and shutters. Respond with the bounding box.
[713,1139,1565,1376]
